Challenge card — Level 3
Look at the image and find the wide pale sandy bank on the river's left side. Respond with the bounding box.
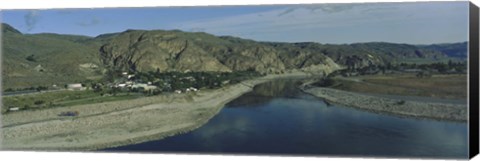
[1,72,306,151]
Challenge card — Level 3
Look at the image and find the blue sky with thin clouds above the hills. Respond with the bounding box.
[1,2,468,44]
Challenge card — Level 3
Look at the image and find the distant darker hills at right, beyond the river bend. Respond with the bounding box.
[267,42,458,67]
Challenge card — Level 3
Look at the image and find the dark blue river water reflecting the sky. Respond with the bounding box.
[102,80,468,159]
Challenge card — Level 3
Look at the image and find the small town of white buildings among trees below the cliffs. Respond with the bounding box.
[2,71,261,116]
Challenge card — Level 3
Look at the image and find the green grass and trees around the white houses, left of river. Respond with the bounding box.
[2,71,260,113]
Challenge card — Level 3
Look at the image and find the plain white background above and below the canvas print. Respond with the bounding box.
[0,0,480,161]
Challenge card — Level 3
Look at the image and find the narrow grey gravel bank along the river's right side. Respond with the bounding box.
[302,87,468,122]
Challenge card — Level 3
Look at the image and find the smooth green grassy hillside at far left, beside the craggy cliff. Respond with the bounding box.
[2,29,104,88]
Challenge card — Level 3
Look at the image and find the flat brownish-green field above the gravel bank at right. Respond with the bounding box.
[331,74,467,99]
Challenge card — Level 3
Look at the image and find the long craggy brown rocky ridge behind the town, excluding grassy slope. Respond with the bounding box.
[100,31,339,74]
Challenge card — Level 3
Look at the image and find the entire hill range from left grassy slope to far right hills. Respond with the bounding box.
[2,24,464,88]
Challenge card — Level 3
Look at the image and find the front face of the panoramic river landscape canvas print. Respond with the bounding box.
[1,1,469,159]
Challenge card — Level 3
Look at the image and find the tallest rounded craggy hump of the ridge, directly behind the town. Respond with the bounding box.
[100,31,231,72]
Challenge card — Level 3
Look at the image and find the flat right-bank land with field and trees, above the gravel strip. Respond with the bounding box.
[312,58,467,99]
